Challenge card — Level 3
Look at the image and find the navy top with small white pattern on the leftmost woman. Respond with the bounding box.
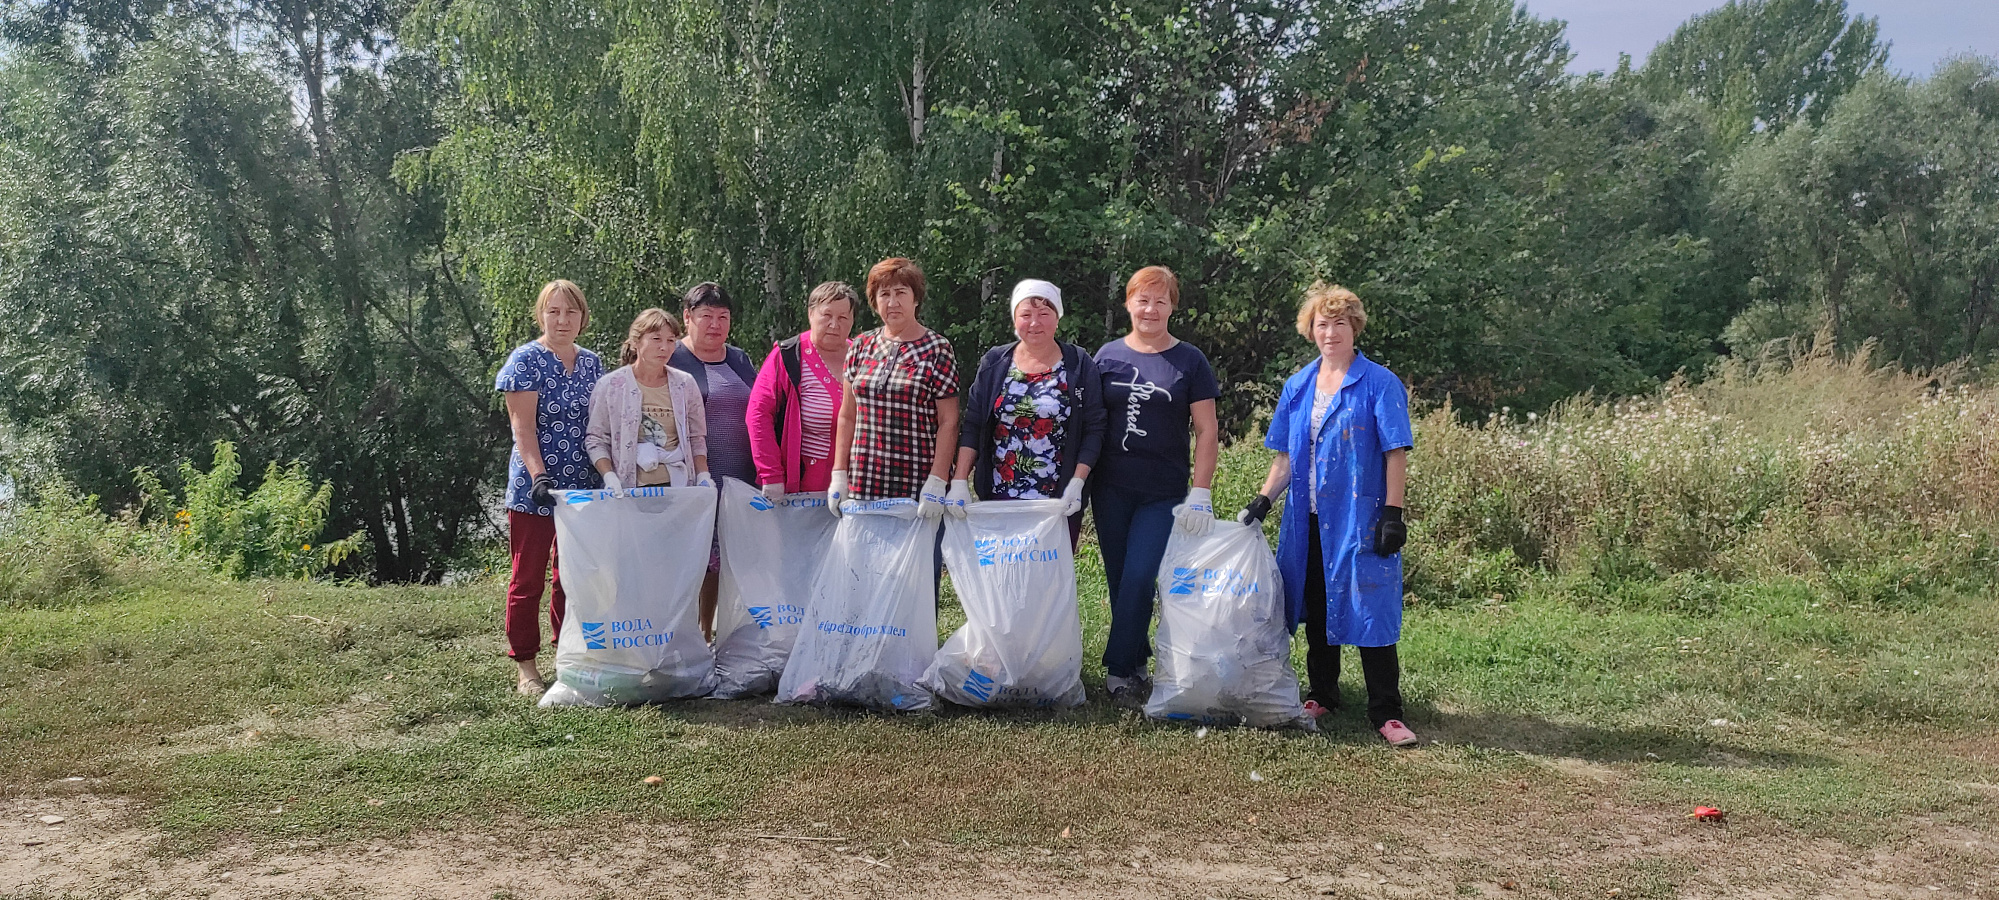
[494,340,604,516]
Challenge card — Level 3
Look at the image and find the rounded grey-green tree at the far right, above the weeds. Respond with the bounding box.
[1719,58,1999,366]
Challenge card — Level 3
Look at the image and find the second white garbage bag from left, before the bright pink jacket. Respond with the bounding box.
[714,478,840,700]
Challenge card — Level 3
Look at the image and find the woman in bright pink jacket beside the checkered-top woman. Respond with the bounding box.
[750,282,860,502]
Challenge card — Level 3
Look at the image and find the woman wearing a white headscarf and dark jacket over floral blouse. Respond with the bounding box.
[948,278,1105,548]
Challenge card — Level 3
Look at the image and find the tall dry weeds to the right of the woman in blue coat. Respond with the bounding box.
[1409,344,1999,600]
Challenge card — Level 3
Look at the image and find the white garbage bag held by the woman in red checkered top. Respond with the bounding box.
[778,500,938,712]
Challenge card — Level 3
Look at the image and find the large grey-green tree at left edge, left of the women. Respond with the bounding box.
[0,2,504,580]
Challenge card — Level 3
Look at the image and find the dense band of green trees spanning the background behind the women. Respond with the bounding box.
[0,0,1999,580]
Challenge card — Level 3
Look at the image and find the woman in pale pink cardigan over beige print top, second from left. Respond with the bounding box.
[584,308,716,496]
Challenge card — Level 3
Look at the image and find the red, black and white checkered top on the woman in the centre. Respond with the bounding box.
[846,328,958,500]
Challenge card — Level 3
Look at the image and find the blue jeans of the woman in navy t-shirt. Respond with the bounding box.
[1089,484,1183,678]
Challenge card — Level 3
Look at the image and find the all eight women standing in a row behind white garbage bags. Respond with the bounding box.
[496,258,1415,746]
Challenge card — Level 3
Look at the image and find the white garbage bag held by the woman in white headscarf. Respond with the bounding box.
[924,500,1083,708]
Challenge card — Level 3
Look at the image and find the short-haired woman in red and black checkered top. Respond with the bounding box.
[826,256,958,520]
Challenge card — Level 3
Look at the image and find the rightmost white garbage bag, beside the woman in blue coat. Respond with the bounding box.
[1145,522,1313,730]
